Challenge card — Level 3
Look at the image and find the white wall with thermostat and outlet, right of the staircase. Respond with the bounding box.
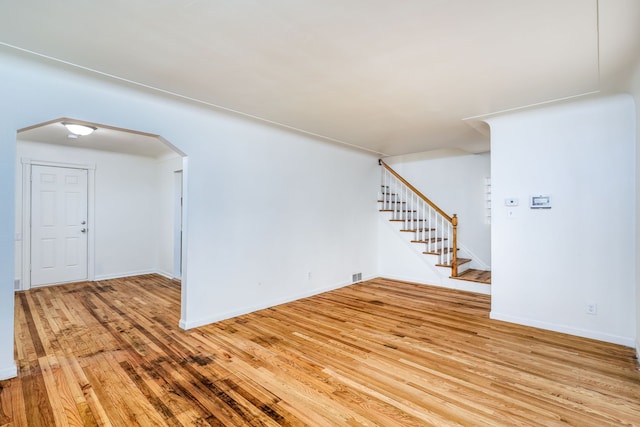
[488,95,636,346]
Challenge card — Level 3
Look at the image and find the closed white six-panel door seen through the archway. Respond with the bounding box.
[31,165,89,286]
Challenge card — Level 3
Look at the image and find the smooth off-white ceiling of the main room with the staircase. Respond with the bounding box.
[0,0,640,155]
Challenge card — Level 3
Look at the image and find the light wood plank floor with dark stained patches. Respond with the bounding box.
[0,276,640,427]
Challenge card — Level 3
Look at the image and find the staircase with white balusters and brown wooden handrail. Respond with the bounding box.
[378,160,491,285]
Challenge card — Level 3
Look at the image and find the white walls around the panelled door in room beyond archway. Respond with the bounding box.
[15,141,181,280]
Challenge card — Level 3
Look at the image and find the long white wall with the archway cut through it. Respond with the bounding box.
[0,47,378,376]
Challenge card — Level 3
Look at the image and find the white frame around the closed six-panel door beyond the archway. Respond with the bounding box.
[20,157,96,290]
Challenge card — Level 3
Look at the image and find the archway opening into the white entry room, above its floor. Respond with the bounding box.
[15,118,187,306]
